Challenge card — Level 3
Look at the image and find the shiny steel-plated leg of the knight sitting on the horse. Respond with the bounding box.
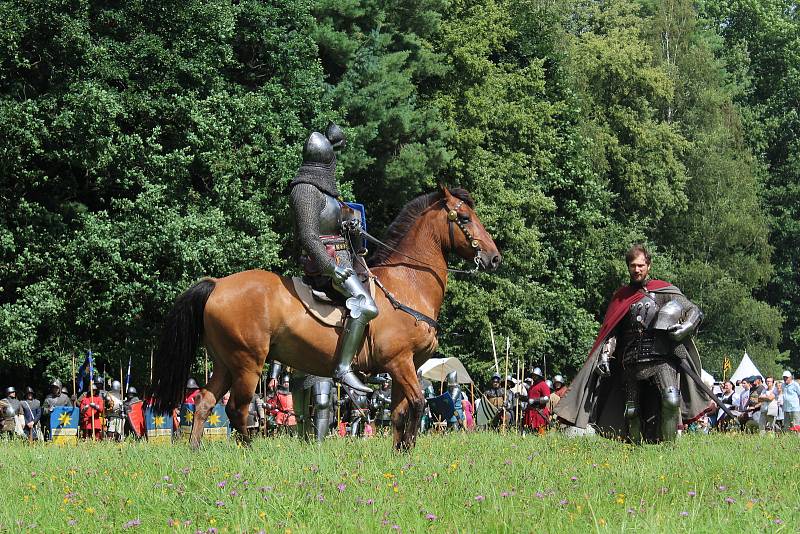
[334,275,378,393]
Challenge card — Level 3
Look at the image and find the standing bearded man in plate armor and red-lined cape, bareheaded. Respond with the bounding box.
[556,245,710,442]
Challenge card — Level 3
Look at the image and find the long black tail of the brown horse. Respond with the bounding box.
[151,278,217,411]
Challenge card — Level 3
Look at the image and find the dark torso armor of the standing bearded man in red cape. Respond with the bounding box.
[622,293,669,366]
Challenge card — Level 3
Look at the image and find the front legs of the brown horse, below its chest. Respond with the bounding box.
[387,355,425,450]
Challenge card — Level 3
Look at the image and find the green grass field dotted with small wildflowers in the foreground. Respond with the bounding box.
[0,433,800,533]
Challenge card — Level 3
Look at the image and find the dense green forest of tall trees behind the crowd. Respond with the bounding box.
[0,0,800,386]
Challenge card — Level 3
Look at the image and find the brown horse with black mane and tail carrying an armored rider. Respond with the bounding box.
[153,188,500,449]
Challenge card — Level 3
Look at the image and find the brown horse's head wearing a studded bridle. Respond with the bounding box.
[436,186,502,271]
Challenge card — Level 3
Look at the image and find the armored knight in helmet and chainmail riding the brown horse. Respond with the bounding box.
[289,123,378,393]
